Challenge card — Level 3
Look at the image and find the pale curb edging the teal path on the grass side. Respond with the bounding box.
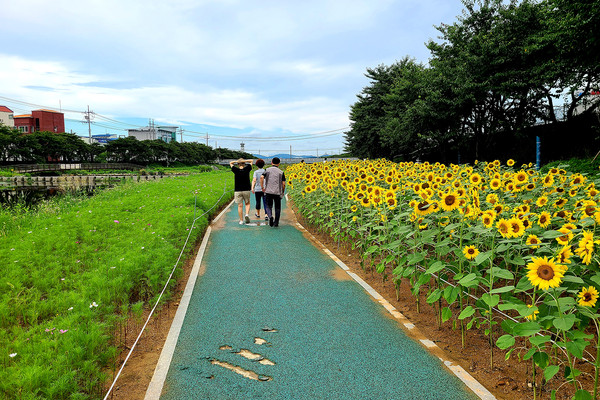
[144,201,233,400]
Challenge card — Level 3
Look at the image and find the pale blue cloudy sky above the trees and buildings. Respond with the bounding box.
[0,0,463,155]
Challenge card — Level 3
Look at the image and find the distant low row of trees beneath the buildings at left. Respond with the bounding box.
[0,124,252,165]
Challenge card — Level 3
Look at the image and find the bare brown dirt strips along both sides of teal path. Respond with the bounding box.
[106,203,582,400]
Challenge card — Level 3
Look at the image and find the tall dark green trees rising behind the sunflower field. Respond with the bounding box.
[346,0,600,162]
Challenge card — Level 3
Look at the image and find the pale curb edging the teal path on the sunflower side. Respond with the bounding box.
[296,221,497,400]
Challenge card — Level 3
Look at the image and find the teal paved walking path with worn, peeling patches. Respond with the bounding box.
[146,199,489,400]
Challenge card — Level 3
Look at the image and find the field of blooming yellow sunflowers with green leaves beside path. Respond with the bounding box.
[286,160,600,399]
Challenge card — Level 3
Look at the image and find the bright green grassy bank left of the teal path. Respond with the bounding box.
[0,171,233,399]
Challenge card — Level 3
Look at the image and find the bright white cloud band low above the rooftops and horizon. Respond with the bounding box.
[0,56,348,133]
